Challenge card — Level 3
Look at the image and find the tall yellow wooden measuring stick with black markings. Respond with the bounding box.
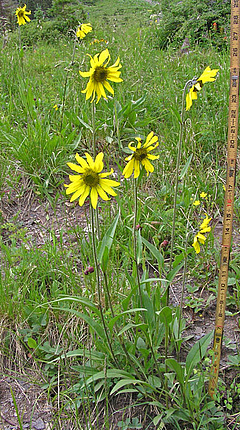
[208,0,240,397]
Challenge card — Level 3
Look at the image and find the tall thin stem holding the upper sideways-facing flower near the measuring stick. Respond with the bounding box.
[166,80,192,305]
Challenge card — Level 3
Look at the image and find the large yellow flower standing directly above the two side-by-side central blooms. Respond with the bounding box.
[79,49,122,103]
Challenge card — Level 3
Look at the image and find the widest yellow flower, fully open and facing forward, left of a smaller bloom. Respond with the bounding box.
[65,152,120,209]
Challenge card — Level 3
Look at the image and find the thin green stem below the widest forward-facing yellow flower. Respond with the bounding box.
[90,205,118,367]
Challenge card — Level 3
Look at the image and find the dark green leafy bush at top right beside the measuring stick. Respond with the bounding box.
[154,0,230,49]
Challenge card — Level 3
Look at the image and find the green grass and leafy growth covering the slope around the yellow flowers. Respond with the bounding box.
[0,0,240,430]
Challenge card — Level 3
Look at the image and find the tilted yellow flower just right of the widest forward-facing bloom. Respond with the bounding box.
[123,131,159,179]
